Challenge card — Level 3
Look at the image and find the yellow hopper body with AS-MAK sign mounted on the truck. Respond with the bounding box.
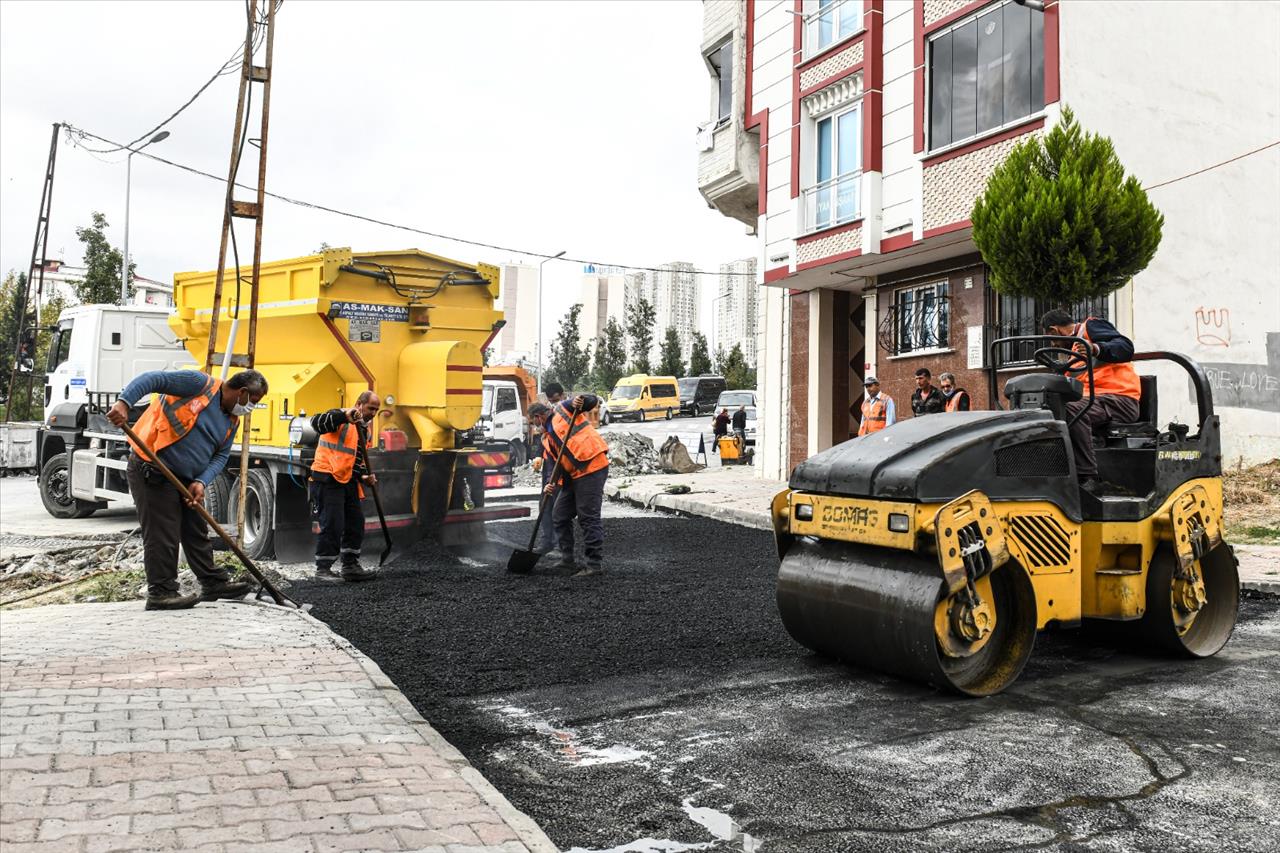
[170,248,502,451]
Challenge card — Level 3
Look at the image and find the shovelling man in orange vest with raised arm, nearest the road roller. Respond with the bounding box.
[529,394,609,578]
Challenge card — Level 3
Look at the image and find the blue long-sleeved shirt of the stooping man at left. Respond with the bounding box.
[120,370,234,485]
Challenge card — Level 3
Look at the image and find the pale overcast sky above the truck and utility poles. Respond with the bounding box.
[0,0,755,343]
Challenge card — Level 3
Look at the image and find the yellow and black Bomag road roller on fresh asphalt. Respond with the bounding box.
[772,336,1239,697]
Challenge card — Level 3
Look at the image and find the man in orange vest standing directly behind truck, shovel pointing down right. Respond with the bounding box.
[307,391,383,581]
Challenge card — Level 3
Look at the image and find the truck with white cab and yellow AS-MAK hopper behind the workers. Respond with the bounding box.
[41,248,529,561]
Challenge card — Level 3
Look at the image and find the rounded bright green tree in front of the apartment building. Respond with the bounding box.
[970,108,1165,300]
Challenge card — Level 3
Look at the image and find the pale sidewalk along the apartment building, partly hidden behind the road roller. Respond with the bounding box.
[604,465,1280,596]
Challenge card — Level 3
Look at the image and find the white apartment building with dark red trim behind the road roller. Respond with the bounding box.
[698,0,1280,476]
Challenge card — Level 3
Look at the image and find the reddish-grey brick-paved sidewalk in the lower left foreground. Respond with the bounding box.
[0,602,556,853]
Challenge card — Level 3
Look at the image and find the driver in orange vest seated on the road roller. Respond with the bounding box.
[1041,309,1142,492]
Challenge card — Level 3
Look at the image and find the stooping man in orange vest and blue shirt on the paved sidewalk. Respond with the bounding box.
[106,370,266,610]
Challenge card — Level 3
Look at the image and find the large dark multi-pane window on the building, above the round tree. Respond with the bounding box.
[928,0,1044,151]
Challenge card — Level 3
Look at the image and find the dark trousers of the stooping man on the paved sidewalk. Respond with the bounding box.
[124,453,230,596]
